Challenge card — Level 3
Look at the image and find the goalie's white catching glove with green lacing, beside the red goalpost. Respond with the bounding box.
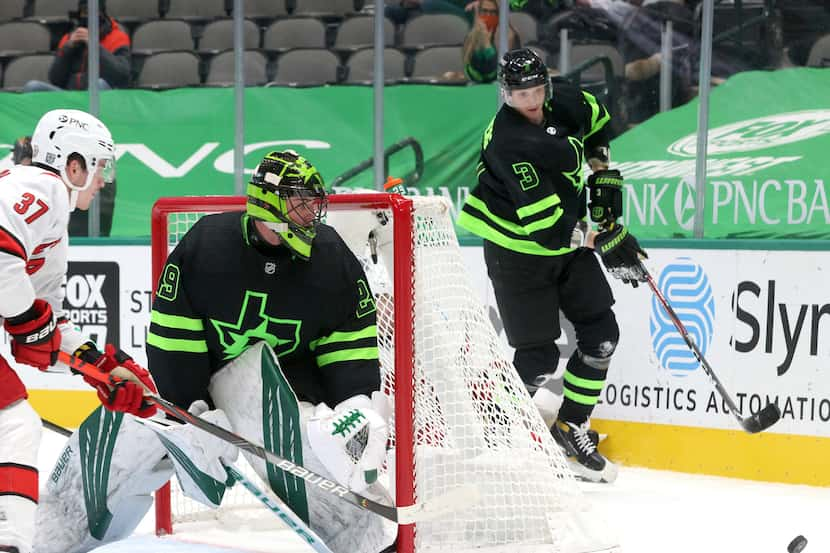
[306,395,389,493]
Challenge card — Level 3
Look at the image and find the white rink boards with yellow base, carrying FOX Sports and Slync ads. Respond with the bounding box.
[17,240,830,485]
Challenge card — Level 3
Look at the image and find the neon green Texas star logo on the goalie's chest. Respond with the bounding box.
[210,290,302,359]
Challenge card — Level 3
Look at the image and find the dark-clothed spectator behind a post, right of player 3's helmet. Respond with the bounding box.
[620,0,698,124]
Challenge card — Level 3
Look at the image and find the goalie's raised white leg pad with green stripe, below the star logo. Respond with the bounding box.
[209,342,397,553]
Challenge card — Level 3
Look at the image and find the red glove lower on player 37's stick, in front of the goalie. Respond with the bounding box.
[74,342,158,418]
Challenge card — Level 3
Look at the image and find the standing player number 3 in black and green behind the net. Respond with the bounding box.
[458,48,645,481]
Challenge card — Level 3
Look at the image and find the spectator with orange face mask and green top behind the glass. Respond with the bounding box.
[463,0,522,83]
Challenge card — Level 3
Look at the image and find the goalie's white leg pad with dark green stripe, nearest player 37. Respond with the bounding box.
[34,407,173,553]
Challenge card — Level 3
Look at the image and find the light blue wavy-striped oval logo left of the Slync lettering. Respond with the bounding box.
[649,257,715,376]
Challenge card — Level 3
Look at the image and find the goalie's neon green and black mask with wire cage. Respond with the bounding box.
[246,150,326,259]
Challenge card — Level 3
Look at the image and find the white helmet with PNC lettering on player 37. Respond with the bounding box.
[32,109,115,196]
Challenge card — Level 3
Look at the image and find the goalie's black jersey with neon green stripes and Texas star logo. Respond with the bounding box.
[147,212,380,408]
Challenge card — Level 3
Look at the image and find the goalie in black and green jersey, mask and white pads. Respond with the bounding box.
[39,151,396,553]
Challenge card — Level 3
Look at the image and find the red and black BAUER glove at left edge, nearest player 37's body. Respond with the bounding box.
[3,300,61,371]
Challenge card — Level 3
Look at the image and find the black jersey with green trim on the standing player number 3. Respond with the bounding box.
[458,81,610,256]
